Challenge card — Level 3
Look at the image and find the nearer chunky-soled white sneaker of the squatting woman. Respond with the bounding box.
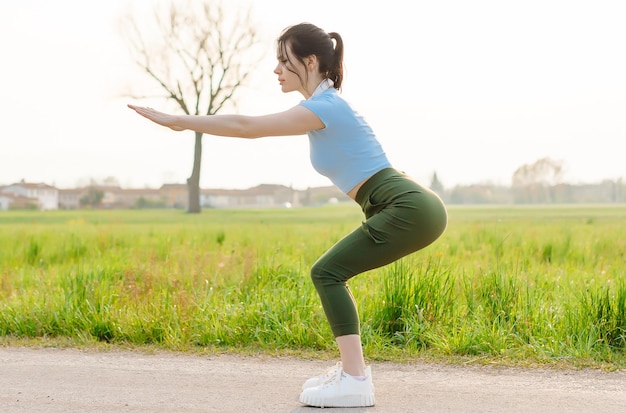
[300,366,375,407]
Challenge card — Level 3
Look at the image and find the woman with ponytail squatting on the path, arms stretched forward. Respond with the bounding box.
[128,23,447,407]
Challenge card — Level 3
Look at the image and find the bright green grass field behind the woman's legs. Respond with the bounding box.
[0,204,626,369]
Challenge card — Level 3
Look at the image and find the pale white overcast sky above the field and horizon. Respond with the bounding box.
[0,0,626,189]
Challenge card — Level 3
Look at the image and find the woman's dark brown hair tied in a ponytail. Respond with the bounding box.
[277,23,343,89]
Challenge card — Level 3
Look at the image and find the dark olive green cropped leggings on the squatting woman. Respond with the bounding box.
[311,168,448,337]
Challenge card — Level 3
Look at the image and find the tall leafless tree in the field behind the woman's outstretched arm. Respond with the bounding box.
[121,0,260,213]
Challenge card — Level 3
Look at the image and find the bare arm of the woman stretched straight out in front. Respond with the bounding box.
[128,104,324,139]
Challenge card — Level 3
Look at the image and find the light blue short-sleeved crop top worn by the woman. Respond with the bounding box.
[300,87,391,193]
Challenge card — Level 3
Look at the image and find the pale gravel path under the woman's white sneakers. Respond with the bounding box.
[0,347,626,413]
